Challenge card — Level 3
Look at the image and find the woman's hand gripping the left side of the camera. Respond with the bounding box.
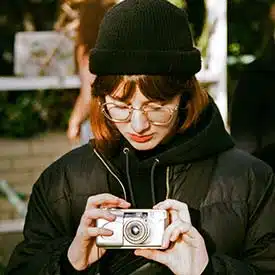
[67,194,130,271]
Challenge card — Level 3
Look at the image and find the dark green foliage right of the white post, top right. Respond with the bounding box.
[227,0,274,98]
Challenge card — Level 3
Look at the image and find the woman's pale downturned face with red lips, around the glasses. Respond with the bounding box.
[105,88,180,150]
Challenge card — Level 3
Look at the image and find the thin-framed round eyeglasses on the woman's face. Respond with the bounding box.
[101,103,178,125]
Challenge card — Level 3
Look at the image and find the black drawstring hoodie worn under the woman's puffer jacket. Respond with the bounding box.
[98,101,233,275]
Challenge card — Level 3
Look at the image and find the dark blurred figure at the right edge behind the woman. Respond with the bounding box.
[230,1,275,169]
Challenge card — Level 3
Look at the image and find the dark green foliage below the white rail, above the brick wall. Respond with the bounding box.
[0,90,77,138]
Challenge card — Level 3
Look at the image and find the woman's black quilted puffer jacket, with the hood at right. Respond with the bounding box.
[5,104,275,275]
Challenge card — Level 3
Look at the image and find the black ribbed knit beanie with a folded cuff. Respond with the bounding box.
[90,0,201,76]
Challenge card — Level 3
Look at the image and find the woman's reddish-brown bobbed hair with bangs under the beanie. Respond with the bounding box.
[90,75,209,154]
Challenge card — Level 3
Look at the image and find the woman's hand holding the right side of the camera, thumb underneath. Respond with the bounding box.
[135,199,209,275]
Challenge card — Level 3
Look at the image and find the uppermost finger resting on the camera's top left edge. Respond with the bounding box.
[86,193,130,209]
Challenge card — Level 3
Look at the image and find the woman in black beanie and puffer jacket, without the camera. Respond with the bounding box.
[5,0,275,275]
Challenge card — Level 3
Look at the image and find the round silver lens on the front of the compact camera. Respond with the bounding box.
[124,219,149,245]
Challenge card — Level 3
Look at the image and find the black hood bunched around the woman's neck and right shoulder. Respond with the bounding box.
[123,99,234,166]
